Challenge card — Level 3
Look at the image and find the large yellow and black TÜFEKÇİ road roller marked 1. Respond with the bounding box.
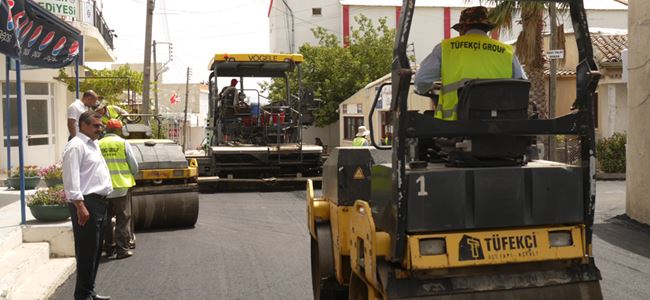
[307,0,602,299]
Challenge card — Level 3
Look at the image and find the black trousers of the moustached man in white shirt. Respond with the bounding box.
[69,194,108,300]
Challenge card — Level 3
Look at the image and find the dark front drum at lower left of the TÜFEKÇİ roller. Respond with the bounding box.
[311,223,348,300]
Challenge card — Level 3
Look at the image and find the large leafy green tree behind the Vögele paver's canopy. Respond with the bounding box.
[262,15,395,126]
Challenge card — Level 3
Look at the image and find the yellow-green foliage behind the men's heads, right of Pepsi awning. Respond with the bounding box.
[59,65,143,104]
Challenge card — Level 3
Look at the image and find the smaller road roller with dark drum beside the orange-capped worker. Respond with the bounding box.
[122,114,199,229]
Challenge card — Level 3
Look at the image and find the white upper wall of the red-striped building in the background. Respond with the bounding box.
[269,0,627,63]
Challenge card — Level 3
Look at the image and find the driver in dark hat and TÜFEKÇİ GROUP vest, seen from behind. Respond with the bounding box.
[414,6,526,121]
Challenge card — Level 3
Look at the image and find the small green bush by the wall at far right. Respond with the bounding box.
[596,132,627,173]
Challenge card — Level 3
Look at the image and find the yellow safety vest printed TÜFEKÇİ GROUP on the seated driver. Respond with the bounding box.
[435,34,513,121]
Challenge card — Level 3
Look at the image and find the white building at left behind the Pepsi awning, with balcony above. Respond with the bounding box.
[0,0,115,170]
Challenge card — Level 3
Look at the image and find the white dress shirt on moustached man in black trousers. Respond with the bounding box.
[63,132,113,201]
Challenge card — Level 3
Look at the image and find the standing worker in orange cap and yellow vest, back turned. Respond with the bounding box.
[99,119,138,259]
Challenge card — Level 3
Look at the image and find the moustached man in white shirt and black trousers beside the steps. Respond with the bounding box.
[63,111,113,300]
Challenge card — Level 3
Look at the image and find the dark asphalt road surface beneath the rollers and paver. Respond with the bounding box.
[53,181,650,300]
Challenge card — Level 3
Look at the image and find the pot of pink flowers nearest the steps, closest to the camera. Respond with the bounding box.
[27,185,70,222]
